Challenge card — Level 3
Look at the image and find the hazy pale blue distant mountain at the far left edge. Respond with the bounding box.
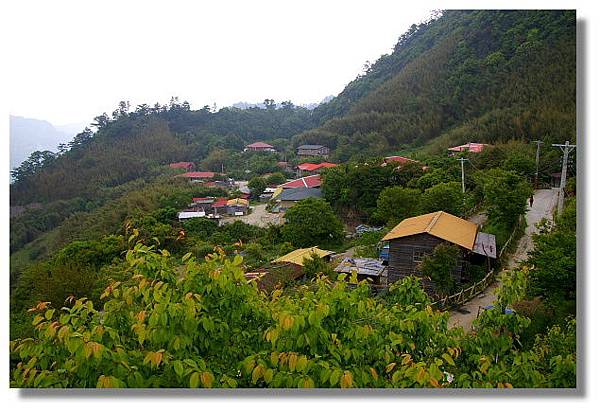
[10,115,85,169]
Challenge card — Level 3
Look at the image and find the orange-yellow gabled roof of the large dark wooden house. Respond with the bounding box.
[383,211,477,250]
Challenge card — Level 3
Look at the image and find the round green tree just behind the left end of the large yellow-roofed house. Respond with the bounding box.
[373,186,421,226]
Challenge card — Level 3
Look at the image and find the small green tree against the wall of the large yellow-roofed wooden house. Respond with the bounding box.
[421,243,460,295]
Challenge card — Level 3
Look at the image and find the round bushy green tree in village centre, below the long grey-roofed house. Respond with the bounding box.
[282,198,344,247]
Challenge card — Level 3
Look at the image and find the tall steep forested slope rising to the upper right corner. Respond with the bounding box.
[296,10,576,160]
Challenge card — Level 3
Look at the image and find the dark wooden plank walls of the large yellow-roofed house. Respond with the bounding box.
[388,233,465,293]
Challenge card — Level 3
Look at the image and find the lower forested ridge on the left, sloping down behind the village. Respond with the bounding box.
[11,101,314,205]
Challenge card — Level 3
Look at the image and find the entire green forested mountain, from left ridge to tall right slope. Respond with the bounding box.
[10,10,576,262]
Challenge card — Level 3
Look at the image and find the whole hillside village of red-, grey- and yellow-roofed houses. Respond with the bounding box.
[163,138,555,312]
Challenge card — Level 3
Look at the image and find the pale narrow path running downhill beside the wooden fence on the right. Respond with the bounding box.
[448,189,558,331]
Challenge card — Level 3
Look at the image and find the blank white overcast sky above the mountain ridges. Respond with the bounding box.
[5,0,432,125]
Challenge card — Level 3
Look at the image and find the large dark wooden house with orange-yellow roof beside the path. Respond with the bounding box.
[382,211,496,292]
